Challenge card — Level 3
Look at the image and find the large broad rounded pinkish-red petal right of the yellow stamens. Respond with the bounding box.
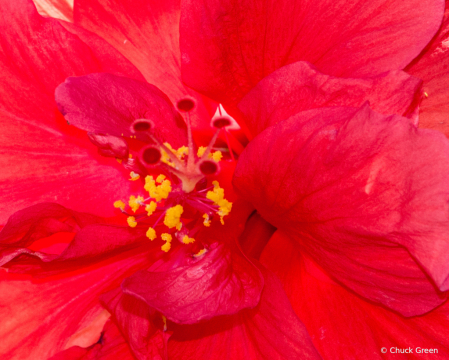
[234,106,449,315]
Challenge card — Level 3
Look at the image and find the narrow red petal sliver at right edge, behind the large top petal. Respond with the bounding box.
[406,2,449,136]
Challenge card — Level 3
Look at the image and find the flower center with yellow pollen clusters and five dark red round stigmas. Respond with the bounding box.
[114,98,232,252]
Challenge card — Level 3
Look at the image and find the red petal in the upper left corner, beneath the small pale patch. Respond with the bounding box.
[0,0,142,128]
